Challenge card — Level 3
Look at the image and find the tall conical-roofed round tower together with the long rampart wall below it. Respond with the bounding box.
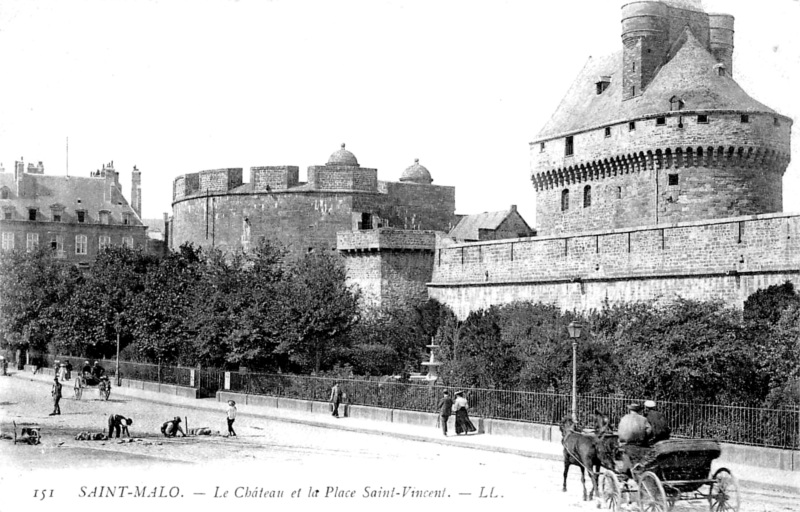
[429,0,800,318]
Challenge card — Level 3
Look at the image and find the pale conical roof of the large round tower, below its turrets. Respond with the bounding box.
[536,28,775,140]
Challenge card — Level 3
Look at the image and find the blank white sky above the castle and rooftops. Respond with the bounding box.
[0,0,800,224]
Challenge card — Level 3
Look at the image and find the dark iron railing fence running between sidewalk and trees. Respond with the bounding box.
[40,356,800,450]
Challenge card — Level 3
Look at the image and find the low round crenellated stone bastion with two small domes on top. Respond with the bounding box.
[170,144,455,255]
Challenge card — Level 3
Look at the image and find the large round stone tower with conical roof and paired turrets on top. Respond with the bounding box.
[530,0,792,235]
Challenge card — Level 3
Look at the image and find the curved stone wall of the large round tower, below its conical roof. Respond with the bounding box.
[531,111,791,235]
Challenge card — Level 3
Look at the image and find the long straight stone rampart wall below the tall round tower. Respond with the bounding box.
[428,214,800,318]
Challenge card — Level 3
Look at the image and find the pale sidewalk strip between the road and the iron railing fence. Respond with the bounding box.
[11,371,800,494]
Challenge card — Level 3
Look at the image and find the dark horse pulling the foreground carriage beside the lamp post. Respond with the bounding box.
[560,416,615,501]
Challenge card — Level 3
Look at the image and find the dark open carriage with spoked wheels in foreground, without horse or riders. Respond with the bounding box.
[600,439,739,512]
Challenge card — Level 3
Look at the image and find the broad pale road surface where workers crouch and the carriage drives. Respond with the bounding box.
[0,378,800,512]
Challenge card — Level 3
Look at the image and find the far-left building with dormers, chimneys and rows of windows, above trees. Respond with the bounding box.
[0,161,146,266]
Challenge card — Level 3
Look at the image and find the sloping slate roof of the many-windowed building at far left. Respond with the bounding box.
[0,172,142,226]
